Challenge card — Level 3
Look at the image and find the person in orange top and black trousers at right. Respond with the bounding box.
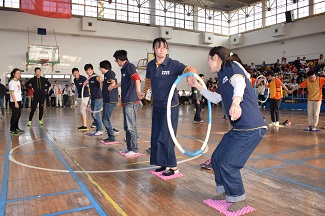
[265,71,289,127]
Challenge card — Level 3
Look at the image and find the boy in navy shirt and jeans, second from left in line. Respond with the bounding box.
[84,64,103,136]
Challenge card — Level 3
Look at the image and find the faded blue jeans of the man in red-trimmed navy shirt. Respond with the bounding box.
[123,103,139,152]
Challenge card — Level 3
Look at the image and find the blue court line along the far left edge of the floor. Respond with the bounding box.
[0,132,11,216]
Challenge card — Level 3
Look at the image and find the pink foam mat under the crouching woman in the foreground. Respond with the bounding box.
[203,199,255,216]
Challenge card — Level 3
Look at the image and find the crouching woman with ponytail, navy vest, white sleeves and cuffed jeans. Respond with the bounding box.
[188,46,267,212]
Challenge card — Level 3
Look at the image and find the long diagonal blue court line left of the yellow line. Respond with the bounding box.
[39,127,107,215]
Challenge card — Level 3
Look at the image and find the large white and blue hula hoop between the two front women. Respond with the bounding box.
[167,72,212,157]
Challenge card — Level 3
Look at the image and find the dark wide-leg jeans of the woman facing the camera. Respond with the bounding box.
[150,105,179,167]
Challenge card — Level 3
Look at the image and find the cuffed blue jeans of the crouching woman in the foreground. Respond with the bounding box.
[211,128,266,202]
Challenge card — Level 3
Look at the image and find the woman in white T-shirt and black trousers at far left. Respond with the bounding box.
[9,68,24,135]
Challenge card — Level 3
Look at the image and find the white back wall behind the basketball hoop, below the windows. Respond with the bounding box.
[0,11,228,89]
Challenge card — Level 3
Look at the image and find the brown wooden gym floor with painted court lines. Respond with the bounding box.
[0,106,325,216]
